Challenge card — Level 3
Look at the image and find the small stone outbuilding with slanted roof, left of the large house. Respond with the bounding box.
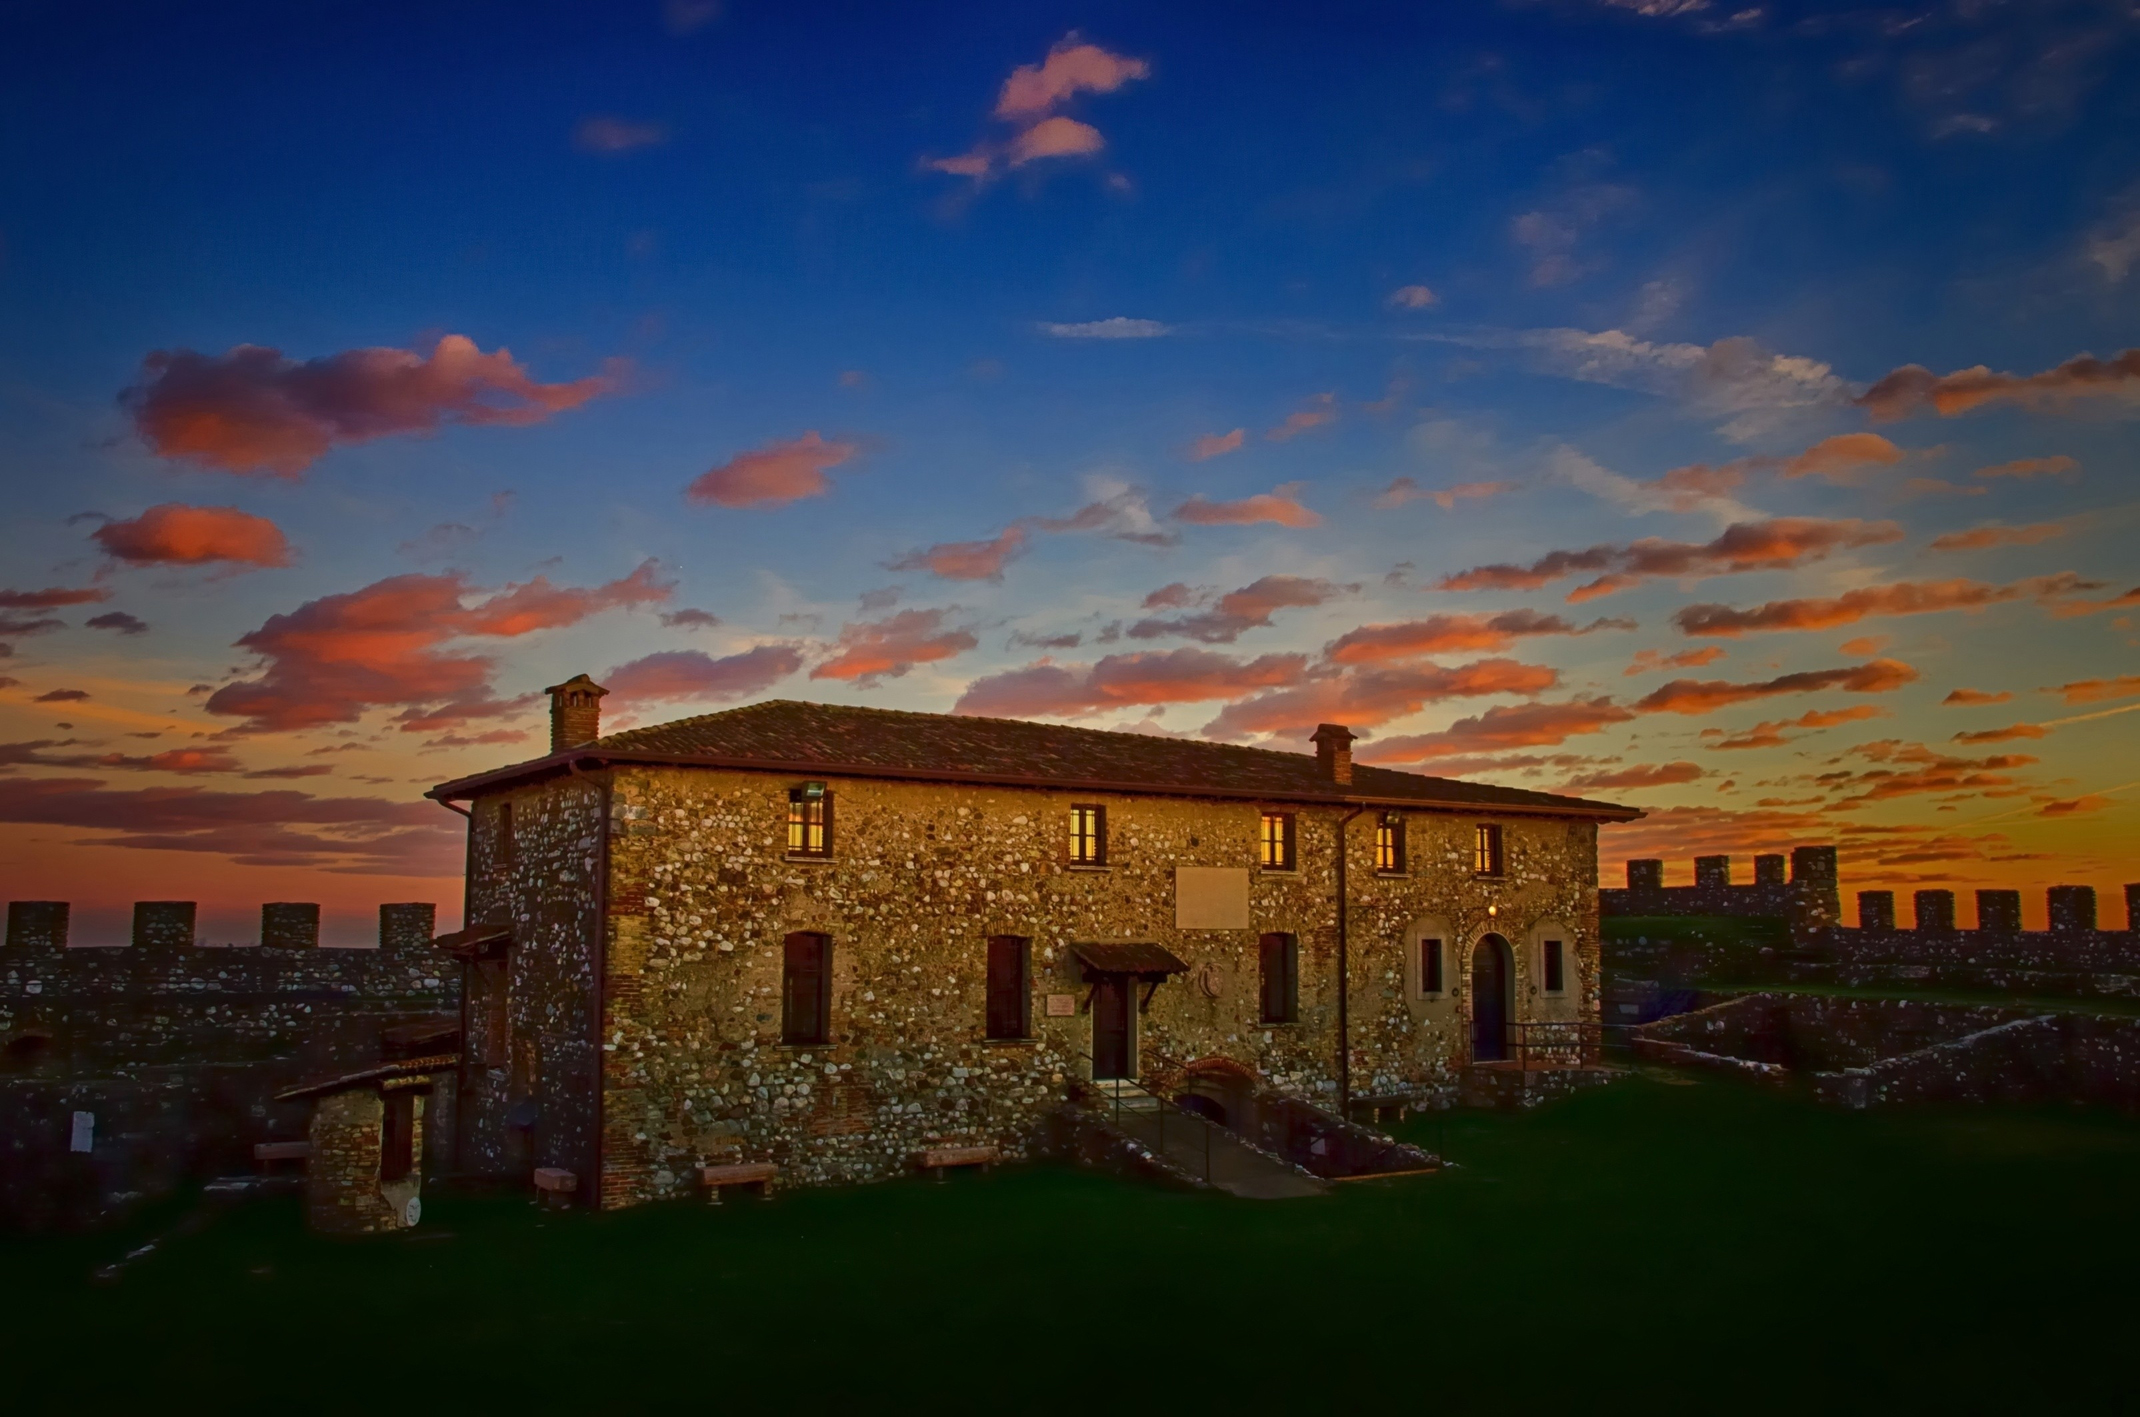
[276,1053,460,1235]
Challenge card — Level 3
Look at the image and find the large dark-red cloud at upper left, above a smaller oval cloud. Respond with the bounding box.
[120,334,623,477]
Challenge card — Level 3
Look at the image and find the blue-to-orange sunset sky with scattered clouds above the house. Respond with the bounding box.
[0,0,2140,942]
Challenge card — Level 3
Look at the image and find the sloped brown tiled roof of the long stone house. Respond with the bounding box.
[430,698,1641,818]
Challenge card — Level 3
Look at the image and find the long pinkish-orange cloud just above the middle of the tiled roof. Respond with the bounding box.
[952,649,1308,719]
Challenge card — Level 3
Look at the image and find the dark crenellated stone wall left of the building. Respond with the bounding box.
[0,901,458,1224]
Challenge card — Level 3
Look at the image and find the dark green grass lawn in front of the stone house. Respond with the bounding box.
[0,1072,2140,1413]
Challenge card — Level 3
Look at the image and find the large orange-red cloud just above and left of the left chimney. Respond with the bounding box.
[205,561,670,732]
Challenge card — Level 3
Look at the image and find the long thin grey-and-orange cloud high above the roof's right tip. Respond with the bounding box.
[1438,516,1902,601]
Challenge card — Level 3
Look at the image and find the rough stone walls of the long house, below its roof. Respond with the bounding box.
[481,766,1599,1205]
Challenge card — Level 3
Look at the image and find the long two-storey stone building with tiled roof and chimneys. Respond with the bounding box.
[430,676,1639,1207]
